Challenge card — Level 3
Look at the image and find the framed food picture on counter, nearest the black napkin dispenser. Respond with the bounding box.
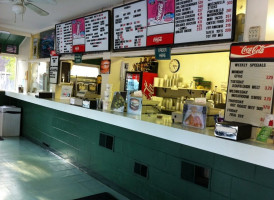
[183,104,207,129]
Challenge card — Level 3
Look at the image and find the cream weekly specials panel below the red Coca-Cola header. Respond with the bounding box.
[225,62,274,126]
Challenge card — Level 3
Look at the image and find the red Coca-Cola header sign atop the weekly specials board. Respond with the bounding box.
[230,44,274,59]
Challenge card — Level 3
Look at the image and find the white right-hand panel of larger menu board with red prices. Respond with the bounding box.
[174,0,235,44]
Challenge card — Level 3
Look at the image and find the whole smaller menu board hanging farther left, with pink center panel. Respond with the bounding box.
[55,10,111,54]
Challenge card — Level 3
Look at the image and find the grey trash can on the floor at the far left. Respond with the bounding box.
[0,106,21,137]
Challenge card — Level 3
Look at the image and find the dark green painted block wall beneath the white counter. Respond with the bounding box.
[5,98,274,200]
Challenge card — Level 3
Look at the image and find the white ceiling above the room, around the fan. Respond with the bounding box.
[0,0,124,34]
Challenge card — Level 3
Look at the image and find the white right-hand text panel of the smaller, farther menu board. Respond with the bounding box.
[85,12,109,51]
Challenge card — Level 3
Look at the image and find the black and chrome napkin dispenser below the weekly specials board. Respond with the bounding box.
[214,121,252,140]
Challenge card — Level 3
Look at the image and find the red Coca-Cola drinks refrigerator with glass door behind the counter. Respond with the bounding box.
[124,71,158,100]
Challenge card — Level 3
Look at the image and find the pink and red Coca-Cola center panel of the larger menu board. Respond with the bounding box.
[147,0,175,46]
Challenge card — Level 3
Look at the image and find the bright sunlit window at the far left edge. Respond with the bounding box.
[0,56,16,91]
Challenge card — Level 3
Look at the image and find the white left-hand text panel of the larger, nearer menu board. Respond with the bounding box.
[113,1,147,50]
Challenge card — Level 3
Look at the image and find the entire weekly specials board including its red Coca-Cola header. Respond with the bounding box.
[225,43,274,127]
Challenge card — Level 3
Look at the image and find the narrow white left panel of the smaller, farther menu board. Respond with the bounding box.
[55,22,72,53]
